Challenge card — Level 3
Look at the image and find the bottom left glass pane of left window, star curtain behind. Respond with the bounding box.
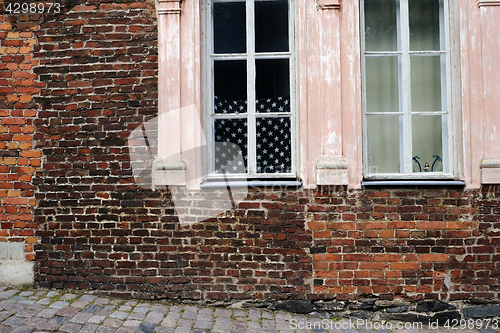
[214,118,247,173]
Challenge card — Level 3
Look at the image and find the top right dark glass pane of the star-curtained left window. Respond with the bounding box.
[255,0,288,52]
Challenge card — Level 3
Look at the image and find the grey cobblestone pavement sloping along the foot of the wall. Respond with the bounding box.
[0,287,495,333]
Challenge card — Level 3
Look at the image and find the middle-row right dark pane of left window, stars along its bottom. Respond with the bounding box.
[255,59,290,112]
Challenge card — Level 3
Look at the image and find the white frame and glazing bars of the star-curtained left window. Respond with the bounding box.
[203,0,299,180]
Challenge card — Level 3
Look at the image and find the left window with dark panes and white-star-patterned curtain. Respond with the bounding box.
[207,0,295,178]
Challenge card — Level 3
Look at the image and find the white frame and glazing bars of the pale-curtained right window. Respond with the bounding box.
[360,0,457,180]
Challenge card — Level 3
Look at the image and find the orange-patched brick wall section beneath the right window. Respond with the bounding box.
[307,186,500,300]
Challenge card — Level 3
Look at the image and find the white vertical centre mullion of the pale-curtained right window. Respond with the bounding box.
[399,0,413,174]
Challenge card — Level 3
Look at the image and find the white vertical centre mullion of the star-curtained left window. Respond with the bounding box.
[246,0,257,175]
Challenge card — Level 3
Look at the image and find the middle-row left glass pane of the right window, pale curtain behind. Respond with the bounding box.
[365,56,399,112]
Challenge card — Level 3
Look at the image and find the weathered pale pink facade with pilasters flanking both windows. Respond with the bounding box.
[154,0,500,189]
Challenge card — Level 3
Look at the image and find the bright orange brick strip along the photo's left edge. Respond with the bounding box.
[0,2,43,261]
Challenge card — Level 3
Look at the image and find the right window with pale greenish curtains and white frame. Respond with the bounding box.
[361,0,453,179]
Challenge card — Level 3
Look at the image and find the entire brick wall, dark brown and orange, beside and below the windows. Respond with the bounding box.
[0,0,500,301]
